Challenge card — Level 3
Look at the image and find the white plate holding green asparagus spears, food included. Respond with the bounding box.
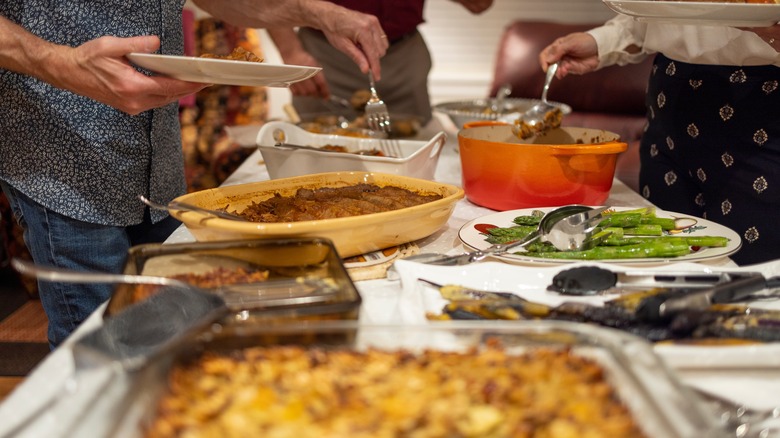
[458,207,742,264]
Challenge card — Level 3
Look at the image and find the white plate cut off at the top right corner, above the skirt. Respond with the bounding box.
[603,0,780,27]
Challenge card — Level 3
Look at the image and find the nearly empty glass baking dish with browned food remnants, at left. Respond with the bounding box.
[105,237,361,323]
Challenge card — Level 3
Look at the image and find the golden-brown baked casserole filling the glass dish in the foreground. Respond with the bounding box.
[145,342,643,438]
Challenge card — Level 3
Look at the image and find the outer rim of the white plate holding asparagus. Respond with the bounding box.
[458,205,742,266]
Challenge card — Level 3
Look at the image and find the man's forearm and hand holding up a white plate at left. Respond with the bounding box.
[0,16,207,114]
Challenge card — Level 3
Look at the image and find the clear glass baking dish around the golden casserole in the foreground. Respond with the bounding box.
[96,321,726,438]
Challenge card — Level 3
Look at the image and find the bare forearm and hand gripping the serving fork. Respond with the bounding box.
[194,0,389,79]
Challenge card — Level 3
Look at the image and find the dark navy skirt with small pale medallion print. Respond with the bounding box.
[639,54,780,265]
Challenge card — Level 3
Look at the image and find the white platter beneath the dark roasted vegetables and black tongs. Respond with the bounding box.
[394,259,780,369]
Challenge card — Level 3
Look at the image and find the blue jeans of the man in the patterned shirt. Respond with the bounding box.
[0,182,180,349]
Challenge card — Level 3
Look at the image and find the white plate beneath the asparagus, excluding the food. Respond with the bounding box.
[458,207,742,265]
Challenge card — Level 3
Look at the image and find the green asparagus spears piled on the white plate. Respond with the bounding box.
[485,207,729,260]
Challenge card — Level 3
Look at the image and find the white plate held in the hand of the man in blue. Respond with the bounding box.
[127,53,321,88]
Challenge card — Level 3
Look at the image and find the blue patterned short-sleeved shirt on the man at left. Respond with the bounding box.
[0,0,186,226]
